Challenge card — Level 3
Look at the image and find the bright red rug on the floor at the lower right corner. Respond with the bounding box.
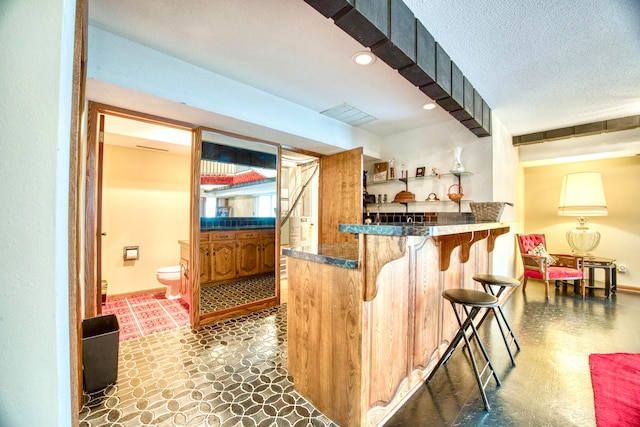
[589,353,640,427]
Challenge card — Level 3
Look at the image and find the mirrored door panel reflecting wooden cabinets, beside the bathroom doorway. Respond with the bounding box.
[199,131,279,318]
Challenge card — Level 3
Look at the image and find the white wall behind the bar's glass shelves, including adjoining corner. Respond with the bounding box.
[365,115,524,277]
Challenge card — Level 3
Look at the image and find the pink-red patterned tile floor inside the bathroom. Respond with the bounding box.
[102,292,189,342]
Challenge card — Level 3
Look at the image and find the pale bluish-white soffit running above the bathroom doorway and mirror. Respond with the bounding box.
[87,26,381,160]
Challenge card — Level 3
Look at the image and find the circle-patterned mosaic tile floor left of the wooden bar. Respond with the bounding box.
[80,305,335,427]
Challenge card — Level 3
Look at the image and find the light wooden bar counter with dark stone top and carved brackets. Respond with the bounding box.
[283,221,509,427]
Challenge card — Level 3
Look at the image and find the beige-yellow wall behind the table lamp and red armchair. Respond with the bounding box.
[524,156,640,288]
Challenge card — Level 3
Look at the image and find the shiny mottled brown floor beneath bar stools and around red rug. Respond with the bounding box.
[385,281,640,427]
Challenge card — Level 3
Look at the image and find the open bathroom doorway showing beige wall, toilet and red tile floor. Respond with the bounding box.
[98,114,192,341]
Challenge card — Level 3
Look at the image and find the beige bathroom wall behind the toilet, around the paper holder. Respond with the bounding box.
[102,145,191,295]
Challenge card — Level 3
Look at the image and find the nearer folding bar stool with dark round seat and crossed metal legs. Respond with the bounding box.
[425,289,500,411]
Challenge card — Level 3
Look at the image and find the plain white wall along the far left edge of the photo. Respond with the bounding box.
[0,0,75,427]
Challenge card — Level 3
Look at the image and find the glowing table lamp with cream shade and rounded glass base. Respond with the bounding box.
[558,172,608,255]
